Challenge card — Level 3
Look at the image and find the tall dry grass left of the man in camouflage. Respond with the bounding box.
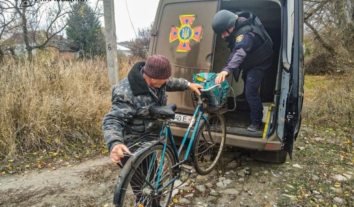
[0,55,141,167]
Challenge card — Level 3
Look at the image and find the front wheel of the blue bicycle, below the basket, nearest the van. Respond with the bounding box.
[192,114,226,175]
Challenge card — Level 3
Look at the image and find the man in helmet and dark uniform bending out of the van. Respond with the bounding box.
[212,10,273,132]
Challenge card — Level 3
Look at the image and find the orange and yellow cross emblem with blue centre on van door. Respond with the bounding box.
[170,14,202,52]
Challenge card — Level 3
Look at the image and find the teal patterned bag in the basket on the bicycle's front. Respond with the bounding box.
[193,72,230,109]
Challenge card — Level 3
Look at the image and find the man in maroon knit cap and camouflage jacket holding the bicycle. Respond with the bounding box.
[102,55,203,207]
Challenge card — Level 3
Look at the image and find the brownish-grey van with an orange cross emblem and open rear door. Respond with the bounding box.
[149,0,304,163]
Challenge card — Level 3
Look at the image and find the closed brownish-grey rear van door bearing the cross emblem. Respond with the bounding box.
[149,0,218,113]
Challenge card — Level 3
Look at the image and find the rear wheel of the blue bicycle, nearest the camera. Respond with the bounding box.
[113,145,176,207]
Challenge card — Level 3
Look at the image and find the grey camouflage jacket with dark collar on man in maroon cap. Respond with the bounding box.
[102,62,189,151]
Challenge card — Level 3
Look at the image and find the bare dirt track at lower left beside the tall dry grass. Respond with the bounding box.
[0,156,119,207]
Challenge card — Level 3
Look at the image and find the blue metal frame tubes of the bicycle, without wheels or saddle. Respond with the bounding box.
[153,96,209,193]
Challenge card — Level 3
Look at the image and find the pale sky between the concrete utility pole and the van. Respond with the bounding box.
[100,0,159,42]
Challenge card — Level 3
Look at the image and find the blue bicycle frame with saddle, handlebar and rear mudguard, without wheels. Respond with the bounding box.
[113,85,224,205]
